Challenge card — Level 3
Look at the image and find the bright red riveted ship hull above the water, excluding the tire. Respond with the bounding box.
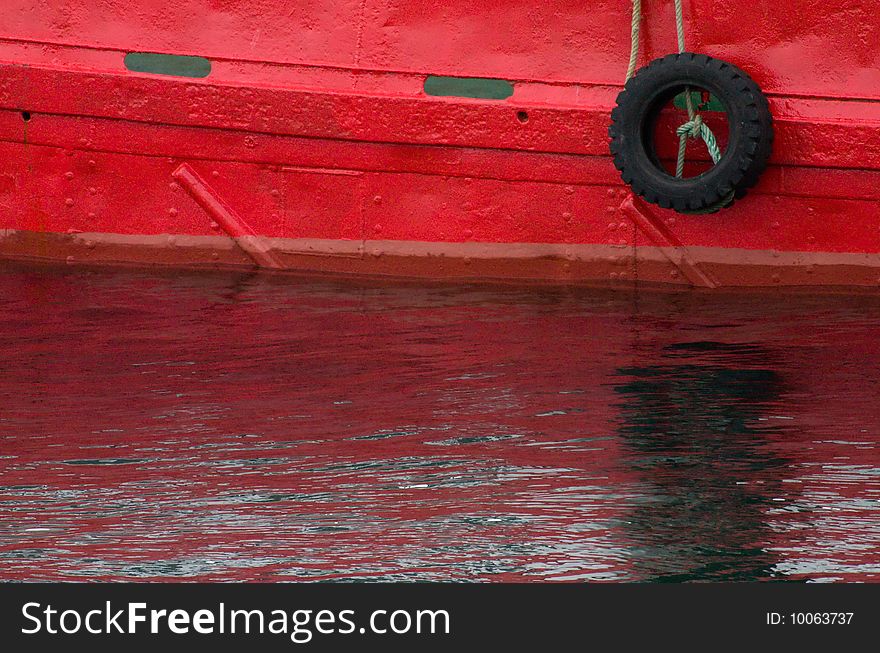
[0,0,880,287]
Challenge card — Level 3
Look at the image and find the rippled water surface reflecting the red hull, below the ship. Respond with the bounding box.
[0,272,880,581]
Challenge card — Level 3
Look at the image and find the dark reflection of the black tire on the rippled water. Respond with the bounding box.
[615,342,787,581]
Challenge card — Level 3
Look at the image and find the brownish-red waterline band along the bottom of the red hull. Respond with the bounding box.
[0,230,880,288]
